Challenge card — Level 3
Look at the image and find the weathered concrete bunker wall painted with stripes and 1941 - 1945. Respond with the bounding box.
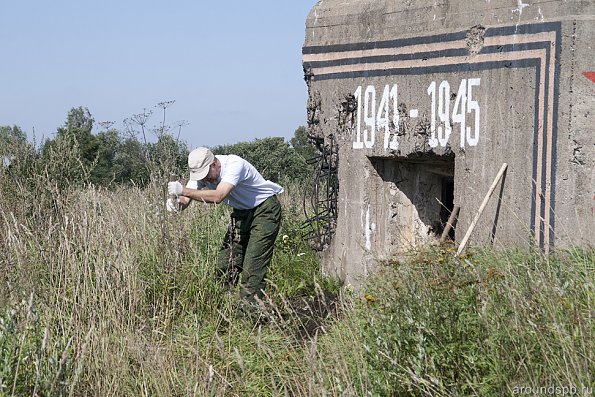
[303,0,595,282]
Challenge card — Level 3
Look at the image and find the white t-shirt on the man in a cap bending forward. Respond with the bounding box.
[186,154,283,210]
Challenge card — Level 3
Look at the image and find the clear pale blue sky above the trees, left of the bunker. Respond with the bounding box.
[0,0,316,147]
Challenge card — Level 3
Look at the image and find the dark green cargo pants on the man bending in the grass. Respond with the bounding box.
[217,196,281,304]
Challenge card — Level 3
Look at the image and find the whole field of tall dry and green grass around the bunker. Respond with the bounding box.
[0,141,595,396]
